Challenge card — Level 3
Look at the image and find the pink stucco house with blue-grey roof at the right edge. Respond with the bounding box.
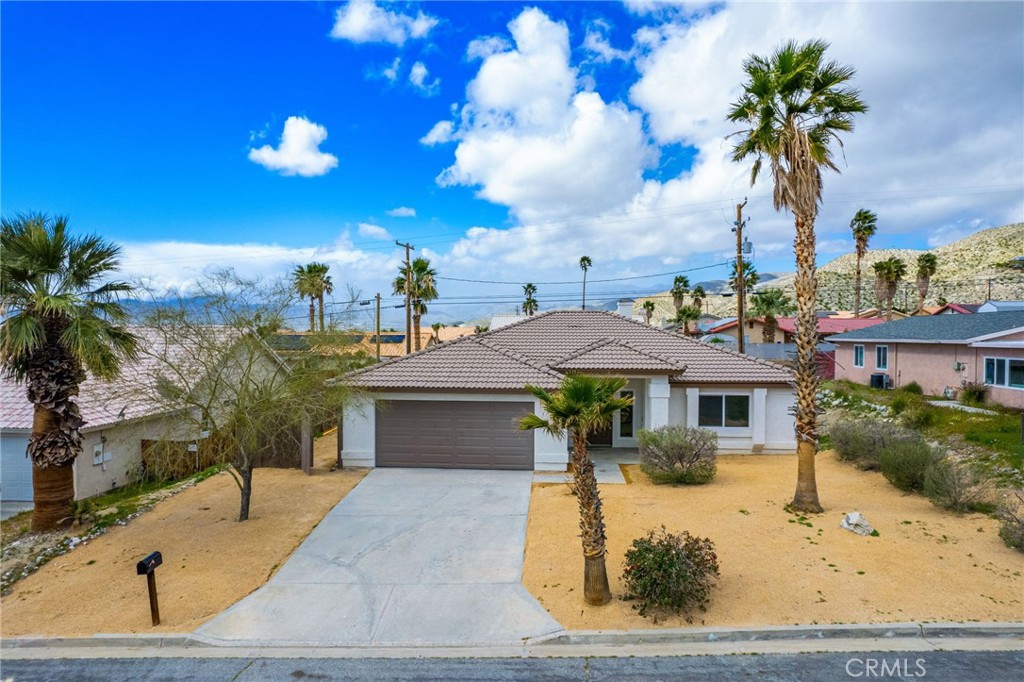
[828,310,1024,408]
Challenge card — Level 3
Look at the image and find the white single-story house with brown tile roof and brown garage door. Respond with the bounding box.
[340,310,796,471]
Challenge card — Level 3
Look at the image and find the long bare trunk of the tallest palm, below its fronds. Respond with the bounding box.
[793,214,821,512]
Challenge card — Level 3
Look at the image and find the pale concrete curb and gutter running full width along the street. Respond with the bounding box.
[0,623,1024,653]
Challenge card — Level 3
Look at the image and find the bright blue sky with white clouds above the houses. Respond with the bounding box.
[0,0,1024,327]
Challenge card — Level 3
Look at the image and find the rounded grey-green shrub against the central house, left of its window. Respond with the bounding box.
[637,425,718,484]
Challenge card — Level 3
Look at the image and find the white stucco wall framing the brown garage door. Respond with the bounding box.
[341,392,569,471]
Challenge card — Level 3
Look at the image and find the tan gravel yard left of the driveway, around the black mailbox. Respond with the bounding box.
[0,434,368,637]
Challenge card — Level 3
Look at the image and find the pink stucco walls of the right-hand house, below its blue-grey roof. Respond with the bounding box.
[836,334,1024,409]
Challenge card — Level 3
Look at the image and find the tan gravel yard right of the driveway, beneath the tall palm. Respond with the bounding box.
[523,453,1024,630]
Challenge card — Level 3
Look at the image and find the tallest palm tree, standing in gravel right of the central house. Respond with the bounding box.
[728,40,867,511]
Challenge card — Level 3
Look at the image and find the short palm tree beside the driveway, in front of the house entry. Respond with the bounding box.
[519,374,633,605]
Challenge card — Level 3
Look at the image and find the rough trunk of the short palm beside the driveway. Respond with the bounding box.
[572,433,611,606]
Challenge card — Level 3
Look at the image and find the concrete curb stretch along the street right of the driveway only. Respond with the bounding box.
[529,623,1024,646]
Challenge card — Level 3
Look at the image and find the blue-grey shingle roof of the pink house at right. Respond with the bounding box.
[828,310,1024,343]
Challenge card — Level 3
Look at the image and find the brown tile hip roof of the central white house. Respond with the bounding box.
[349,310,793,390]
